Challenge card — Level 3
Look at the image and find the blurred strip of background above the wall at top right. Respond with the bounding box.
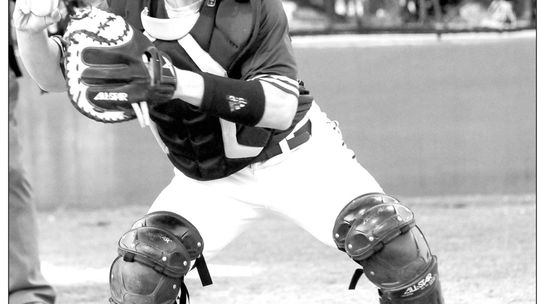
[283,0,536,34]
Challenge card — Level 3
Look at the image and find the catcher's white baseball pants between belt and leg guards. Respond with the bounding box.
[148,103,383,259]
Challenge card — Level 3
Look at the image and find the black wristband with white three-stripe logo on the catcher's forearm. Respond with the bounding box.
[201,73,265,126]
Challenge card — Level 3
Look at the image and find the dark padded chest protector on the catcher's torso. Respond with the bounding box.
[109,0,305,180]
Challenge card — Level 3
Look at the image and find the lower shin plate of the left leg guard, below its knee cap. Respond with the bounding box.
[109,256,183,304]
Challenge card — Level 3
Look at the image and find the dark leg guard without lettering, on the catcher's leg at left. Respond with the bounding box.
[109,211,212,304]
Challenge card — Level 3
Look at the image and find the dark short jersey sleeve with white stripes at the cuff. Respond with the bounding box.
[242,0,298,96]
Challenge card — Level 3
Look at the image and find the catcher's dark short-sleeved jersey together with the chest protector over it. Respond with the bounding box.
[111,0,311,180]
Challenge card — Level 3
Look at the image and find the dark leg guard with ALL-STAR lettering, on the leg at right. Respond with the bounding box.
[334,193,443,304]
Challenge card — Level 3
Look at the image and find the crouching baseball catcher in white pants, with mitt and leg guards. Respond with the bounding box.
[14,0,444,304]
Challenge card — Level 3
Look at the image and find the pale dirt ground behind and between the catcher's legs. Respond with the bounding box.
[39,195,536,304]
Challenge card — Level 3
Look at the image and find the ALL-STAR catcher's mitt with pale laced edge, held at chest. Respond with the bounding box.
[64,8,176,122]
